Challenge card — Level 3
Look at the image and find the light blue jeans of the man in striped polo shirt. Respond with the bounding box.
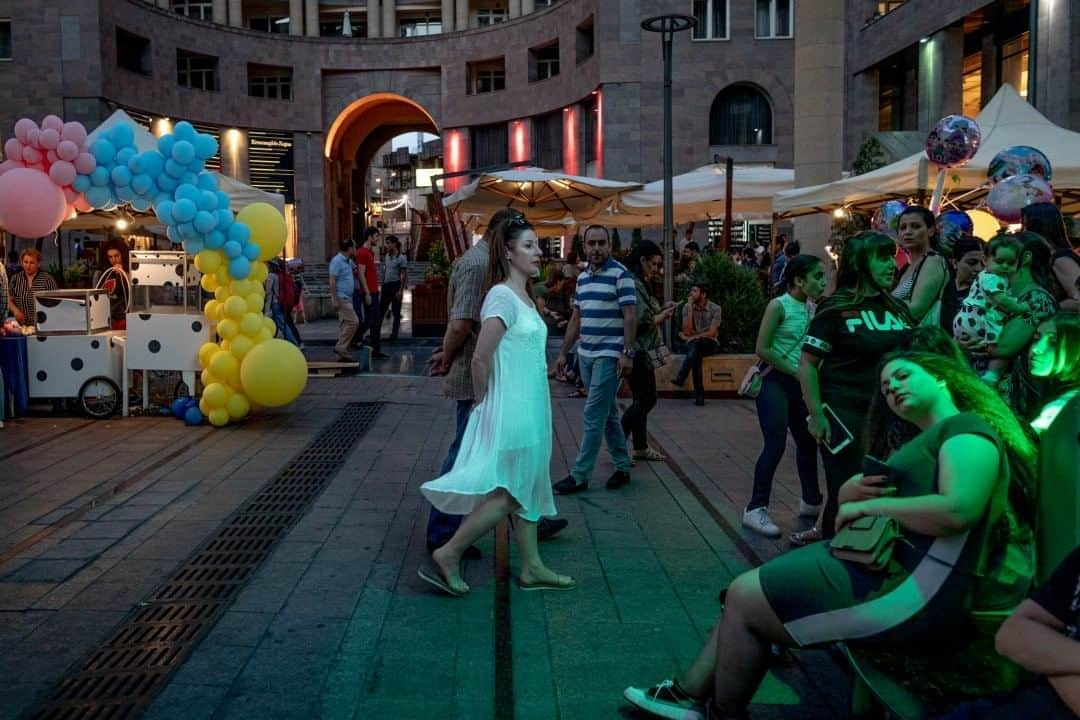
[570,357,630,483]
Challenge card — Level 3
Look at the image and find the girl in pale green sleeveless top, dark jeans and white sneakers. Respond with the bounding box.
[743,255,827,538]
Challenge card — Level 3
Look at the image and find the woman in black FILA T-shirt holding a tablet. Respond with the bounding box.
[792,231,914,545]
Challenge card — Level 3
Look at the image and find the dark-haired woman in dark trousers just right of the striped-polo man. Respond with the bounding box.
[622,240,675,460]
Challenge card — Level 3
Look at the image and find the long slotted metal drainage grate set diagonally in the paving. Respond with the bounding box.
[31,403,382,720]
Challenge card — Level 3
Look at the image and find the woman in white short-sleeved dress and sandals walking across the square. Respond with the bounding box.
[418,217,576,597]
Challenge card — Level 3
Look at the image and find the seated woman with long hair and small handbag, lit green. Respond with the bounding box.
[623,352,1035,718]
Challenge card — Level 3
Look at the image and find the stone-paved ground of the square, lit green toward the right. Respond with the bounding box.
[0,376,846,720]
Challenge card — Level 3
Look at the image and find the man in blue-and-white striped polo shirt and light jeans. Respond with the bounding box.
[554,225,637,494]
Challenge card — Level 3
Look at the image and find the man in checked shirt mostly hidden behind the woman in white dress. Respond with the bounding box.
[428,209,567,558]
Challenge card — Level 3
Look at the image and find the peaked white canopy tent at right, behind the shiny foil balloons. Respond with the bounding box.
[772,84,1080,218]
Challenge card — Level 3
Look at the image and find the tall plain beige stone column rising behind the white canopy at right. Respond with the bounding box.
[794,0,846,262]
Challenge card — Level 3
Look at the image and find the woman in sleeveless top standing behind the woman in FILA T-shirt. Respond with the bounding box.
[892,205,948,325]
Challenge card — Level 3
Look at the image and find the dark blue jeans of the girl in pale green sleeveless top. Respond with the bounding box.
[746,369,821,511]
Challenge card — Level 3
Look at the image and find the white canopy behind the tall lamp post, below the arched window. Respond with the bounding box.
[589,165,795,228]
